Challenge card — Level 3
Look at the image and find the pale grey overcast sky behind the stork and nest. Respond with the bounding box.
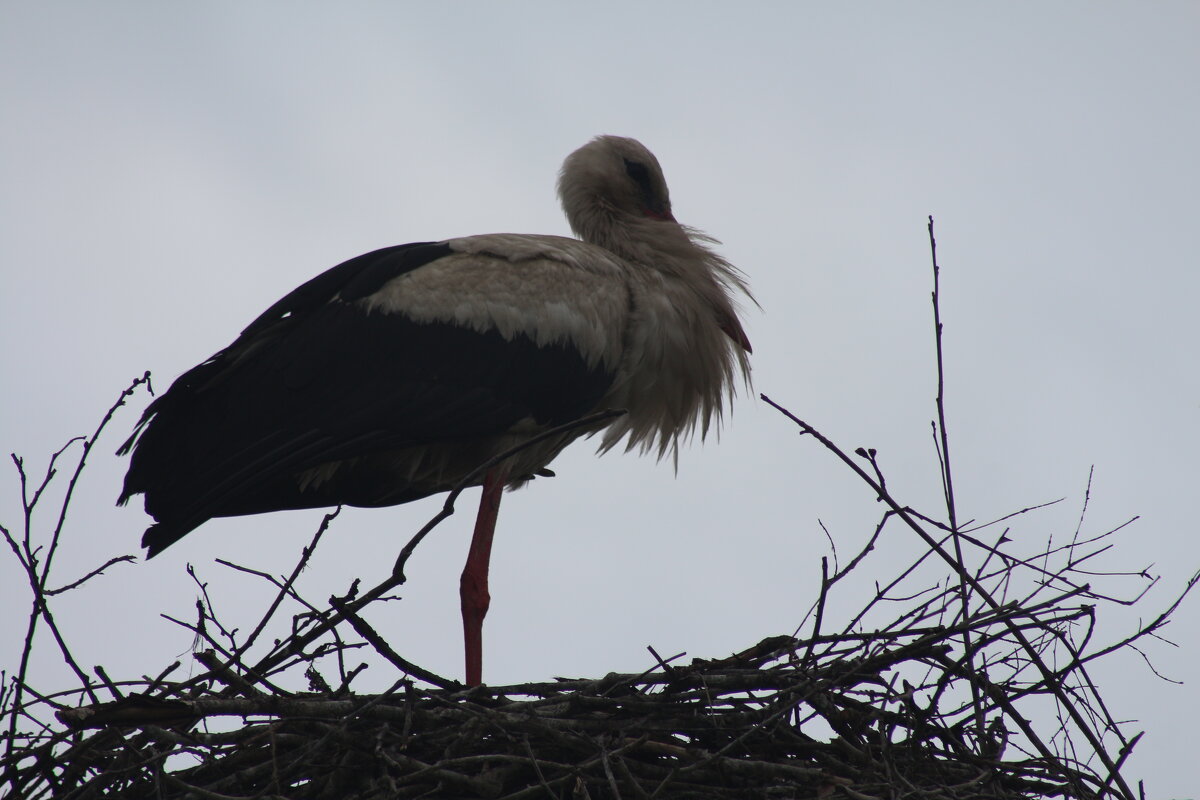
[0,2,1200,798]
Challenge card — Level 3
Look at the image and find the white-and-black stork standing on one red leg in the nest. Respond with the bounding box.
[118,136,754,686]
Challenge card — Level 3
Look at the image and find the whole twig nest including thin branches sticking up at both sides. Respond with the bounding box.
[0,228,1198,800]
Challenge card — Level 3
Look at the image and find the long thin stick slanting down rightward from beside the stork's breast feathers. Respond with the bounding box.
[760,395,1134,800]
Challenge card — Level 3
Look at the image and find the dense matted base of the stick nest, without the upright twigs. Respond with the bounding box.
[39,628,1104,800]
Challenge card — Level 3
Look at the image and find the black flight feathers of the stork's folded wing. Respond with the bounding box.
[119,242,612,555]
